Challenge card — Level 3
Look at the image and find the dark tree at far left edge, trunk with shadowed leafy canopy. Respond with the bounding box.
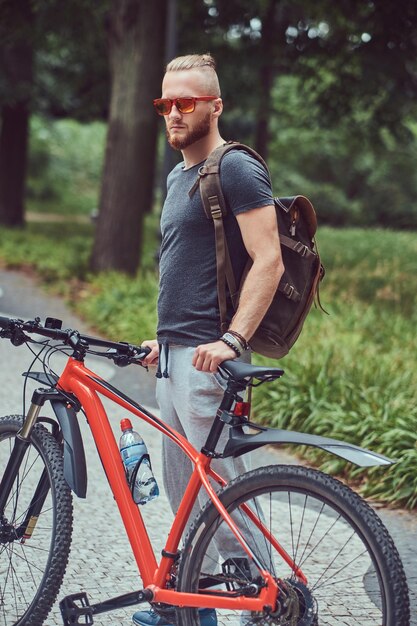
[0,0,109,226]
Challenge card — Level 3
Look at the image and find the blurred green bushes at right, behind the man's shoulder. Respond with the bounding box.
[268,76,417,229]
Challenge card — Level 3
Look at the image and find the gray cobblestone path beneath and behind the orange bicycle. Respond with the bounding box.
[0,270,417,626]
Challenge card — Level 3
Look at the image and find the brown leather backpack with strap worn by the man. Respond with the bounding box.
[190,142,324,359]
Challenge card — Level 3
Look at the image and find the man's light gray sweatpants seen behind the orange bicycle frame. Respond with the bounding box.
[156,346,268,572]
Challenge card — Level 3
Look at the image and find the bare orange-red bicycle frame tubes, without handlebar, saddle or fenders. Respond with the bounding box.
[57,357,282,611]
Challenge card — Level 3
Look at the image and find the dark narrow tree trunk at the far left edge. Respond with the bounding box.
[0,1,33,226]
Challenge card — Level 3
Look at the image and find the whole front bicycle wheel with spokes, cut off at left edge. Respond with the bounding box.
[0,415,73,626]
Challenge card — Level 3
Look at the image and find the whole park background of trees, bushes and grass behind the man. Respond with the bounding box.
[0,0,417,508]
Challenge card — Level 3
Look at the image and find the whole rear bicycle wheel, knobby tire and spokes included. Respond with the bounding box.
[177,465,409,626]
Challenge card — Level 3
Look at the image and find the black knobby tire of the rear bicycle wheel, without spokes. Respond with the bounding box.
[178,465,410,626]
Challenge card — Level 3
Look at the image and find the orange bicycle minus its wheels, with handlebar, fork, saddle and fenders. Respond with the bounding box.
[0,317,404,625]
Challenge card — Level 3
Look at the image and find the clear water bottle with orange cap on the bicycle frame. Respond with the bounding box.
[119,419,159,504]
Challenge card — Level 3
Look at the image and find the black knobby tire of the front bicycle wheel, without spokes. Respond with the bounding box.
[0,415,73,626]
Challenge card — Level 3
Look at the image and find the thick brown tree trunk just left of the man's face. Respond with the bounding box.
[91,0,166,274]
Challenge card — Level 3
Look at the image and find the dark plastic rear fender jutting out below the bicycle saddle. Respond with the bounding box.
[222,426,395,467]
